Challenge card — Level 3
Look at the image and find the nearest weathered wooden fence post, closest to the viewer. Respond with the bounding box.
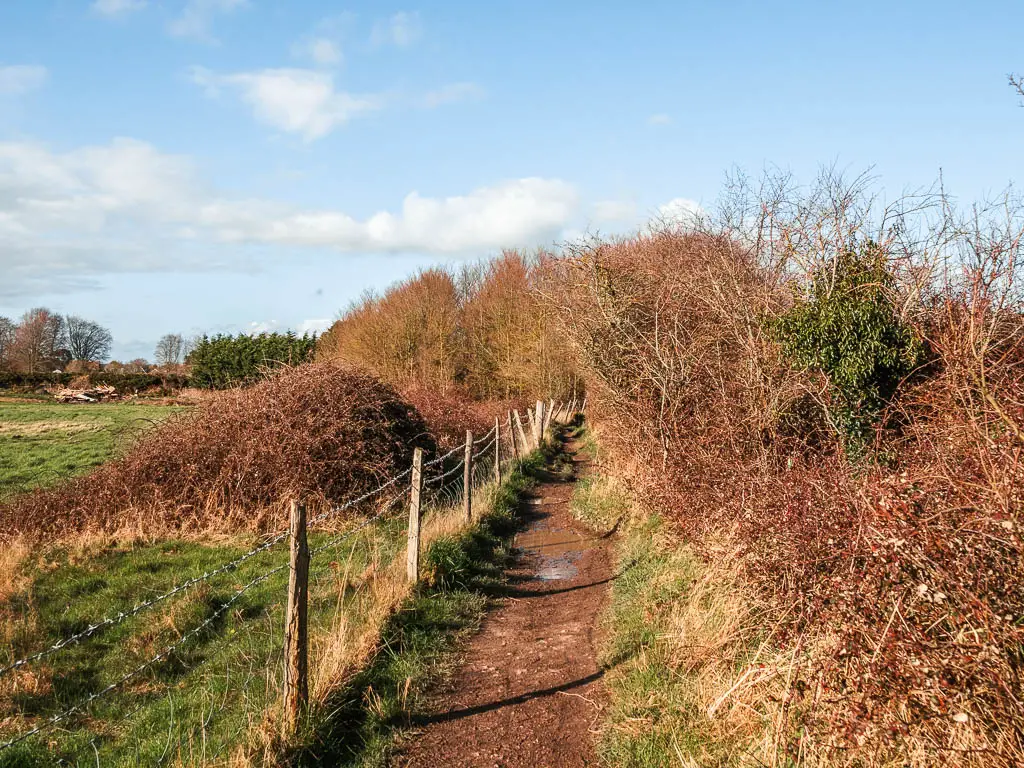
[283,501,309,737]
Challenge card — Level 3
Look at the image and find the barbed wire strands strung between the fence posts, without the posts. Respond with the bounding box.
[0,403,577,753]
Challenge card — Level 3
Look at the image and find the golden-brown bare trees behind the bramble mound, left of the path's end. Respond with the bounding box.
[317,251,577,409]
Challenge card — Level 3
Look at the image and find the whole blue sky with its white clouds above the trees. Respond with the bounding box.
[0,0,1024,358]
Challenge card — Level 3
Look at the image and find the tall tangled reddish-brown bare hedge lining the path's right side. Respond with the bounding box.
[546,174,1024,766]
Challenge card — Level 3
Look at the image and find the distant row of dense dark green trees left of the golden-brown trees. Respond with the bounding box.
[187,331,316,389]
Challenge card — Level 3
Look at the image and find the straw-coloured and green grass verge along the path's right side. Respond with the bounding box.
[572,430,774,768]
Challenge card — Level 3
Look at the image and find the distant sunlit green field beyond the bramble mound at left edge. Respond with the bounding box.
[0,401,181,500]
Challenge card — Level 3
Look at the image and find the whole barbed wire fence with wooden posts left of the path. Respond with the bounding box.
[0,400,578,762]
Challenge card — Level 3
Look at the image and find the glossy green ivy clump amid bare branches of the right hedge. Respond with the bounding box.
[770,242,925,444]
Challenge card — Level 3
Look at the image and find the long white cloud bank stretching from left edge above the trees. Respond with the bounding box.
[0,138,578,296]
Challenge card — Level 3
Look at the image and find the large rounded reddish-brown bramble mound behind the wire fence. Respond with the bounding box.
[0,364,434,536]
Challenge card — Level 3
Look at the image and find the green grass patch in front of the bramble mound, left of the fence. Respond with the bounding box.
[0,519,404,768]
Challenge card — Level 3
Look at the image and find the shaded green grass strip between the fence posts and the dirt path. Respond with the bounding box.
[286,454,544,767]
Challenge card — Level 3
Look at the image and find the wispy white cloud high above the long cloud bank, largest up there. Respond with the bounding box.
[191,68,383,141]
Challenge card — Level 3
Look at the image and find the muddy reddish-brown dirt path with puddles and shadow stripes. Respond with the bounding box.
[395,443,611,768]
